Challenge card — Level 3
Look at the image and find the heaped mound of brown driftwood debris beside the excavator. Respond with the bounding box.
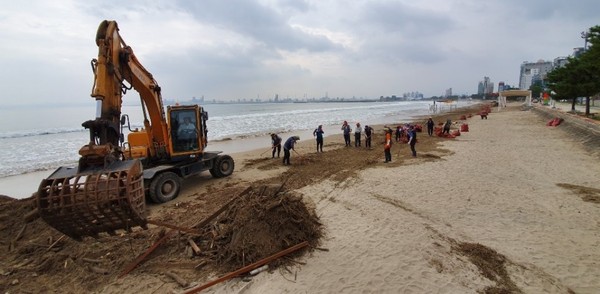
[196,185,322,269]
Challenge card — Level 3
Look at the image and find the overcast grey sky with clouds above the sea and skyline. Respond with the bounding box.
[0,0,600,106]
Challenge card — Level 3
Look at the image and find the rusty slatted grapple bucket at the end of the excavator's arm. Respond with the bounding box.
[36,160,146,240]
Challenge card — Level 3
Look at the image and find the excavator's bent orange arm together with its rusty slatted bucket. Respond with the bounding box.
[36,20,169,239]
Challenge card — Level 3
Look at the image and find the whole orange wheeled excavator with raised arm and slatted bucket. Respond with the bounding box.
[35,20,234,240]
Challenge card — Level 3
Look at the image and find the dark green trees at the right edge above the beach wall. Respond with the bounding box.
[546,26,600,115]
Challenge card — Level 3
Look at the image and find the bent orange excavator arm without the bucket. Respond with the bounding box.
[79,20,168,168]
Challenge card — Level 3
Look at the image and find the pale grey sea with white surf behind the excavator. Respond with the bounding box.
[0,101,470,198]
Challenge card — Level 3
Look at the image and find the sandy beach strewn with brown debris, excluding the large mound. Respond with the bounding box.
[0,103,600,293]
